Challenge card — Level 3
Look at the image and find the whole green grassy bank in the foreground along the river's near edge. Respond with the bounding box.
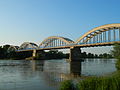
[60,72,120,90]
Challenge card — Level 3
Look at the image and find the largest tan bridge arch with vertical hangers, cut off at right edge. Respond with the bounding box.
[76,23,120,44]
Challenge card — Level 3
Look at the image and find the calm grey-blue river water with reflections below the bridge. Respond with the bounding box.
[0,59,116,90]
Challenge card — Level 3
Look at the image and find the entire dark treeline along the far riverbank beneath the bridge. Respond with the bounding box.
[0,45,113,59]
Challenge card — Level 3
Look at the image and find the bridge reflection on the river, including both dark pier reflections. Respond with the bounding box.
[31,60,81,84]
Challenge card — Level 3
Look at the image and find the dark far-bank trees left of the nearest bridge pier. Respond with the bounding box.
[0,45,66,59]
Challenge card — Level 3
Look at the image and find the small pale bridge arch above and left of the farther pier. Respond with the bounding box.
[18,42,38,50]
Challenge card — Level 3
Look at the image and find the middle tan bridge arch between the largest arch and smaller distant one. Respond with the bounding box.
[39,36,74,48]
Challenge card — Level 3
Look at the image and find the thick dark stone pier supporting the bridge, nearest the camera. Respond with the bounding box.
[69,47,81,60]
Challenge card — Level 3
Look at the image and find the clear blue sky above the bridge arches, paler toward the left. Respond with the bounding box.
[0,0,120,53]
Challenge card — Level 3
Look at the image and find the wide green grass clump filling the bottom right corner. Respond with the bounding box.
[77,76,120,90]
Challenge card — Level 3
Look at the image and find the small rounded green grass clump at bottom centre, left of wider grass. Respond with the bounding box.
[60,80,74,90]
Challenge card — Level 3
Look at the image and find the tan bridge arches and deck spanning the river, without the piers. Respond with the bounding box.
[18,23,120,51]
